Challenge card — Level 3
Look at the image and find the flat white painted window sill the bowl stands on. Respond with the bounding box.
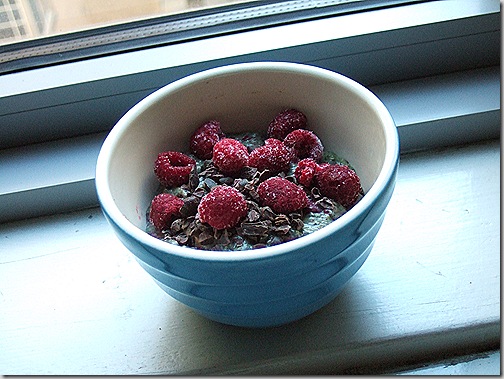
[0,139,500,375]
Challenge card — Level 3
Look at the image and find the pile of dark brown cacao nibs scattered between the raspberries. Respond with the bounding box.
[147,134,358,250]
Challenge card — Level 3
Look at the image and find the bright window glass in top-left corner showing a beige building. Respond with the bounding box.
[0,0,257,45]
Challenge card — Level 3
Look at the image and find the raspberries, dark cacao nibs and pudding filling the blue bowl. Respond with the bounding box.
[147,109,363,250]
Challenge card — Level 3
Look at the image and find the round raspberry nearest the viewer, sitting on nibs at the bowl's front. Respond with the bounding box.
[198,185,248,229]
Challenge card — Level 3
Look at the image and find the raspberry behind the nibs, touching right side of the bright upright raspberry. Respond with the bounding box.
[248,138,293,173]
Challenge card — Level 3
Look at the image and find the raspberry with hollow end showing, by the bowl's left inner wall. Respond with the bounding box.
[154,151,196,188]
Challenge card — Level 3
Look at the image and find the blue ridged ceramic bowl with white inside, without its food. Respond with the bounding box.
[96,62,399,327]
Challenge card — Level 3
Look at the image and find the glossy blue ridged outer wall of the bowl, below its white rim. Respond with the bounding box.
[100,165,395,327]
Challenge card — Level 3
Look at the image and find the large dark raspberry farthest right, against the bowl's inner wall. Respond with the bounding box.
[315,164,362,208]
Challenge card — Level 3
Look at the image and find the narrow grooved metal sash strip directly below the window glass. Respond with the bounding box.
[0,0,429,74]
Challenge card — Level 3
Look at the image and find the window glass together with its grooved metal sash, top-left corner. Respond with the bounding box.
[0,0,396,74]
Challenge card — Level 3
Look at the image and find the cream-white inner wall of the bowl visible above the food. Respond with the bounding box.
[105,64,391,230]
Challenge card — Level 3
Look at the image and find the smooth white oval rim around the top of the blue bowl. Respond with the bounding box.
[95,61,399,261]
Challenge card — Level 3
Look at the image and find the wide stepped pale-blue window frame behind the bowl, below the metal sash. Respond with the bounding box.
[0,0,500,222]
